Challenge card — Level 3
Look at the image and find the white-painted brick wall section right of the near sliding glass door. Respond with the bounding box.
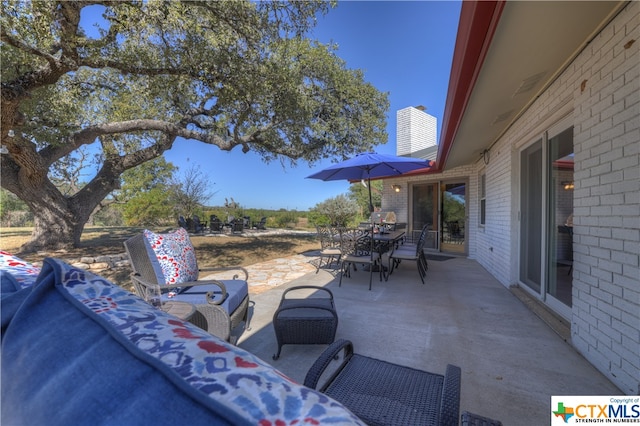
[571,2,640,394]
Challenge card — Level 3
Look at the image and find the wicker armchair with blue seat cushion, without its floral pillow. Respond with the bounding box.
[124,234,249,343]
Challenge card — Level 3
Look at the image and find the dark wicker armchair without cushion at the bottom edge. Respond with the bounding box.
[304,340,461,426]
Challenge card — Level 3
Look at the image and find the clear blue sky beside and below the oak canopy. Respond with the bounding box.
[90,1,461,210]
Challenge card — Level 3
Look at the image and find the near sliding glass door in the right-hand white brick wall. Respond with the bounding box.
[519,120,573,317]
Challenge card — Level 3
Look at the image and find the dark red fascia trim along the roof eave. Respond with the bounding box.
[435,1,506,171]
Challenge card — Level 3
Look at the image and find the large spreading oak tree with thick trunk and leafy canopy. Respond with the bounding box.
[0,0,388,251]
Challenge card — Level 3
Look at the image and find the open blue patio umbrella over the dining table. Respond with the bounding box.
[307,152,433,212]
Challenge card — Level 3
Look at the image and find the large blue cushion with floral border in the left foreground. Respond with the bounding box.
[0,259,362,425]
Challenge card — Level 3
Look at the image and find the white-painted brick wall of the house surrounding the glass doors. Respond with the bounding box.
[382,2,640,395]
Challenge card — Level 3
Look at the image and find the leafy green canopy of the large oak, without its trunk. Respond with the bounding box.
[2,1,389,161]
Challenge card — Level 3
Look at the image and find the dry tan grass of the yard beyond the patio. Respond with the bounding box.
[0,226,320,291]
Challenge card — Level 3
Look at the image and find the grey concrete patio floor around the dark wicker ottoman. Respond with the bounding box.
[238,257,622,426]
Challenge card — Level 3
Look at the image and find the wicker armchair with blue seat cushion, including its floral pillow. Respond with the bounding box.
[124,228,249,343]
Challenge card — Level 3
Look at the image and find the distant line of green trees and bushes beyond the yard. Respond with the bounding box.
[0,175,382,228]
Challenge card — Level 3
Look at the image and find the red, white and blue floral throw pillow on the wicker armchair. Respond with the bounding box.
[144,228,198,285]
